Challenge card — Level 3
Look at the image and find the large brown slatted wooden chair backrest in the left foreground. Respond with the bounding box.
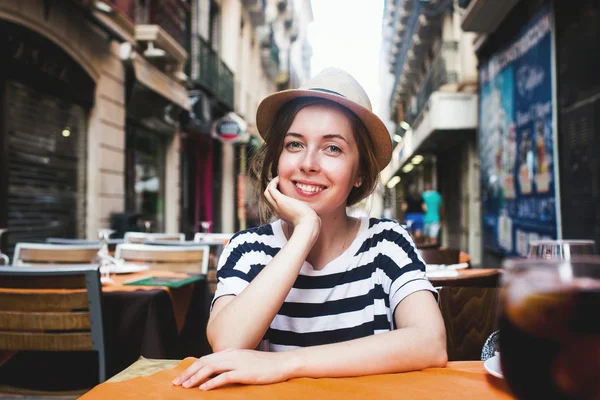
[0,264,106,383]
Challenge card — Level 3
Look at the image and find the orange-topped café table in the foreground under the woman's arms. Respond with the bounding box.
[80,357,514,400]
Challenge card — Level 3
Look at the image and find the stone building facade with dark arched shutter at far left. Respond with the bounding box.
[0,0,189,253]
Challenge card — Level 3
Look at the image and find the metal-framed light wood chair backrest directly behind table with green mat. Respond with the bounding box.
[115,243,210,275]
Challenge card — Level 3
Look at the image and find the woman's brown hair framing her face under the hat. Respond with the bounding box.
[251,97,379,222]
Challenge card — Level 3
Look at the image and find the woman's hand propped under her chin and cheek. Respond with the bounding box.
[265,177,321,229]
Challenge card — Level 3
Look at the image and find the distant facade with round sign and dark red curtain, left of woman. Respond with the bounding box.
[182,0,312,234]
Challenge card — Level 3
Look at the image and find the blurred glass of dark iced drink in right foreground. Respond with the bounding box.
[499,256,600,399]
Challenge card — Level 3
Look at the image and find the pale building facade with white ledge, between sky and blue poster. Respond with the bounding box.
[382,0,481,265]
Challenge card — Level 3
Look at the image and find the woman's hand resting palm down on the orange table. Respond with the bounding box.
[173,349,289,390]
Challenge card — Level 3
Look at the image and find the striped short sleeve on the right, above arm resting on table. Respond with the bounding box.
[385,224,437,315]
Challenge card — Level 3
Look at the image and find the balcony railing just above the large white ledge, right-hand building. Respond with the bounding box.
[406,41,459,125]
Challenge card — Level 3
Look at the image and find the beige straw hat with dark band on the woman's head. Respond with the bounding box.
[256,68,392,171]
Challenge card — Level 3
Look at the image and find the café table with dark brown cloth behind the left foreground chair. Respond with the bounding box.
[0,270,210,388]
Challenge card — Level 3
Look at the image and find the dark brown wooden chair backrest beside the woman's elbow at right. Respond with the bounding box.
[438,286,500,361]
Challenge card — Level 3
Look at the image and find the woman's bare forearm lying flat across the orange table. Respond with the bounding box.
[284,327,447,379]
